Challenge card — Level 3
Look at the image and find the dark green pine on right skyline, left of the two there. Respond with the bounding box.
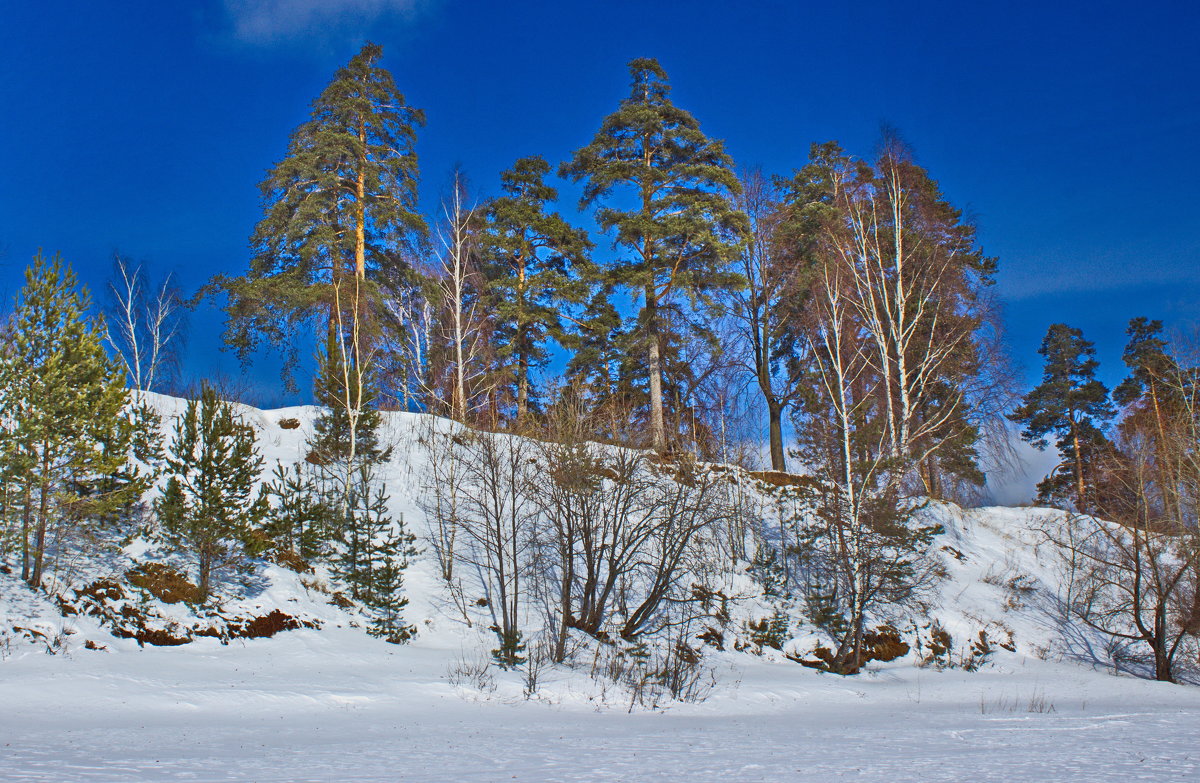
[1009,323,1114,512]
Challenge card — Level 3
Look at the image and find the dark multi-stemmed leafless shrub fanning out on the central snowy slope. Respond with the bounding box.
[536,402,732,656]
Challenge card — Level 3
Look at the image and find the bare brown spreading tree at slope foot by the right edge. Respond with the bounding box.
[1044,338,1200,682]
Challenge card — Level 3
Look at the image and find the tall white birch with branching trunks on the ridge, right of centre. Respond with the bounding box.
[788,136,996,495]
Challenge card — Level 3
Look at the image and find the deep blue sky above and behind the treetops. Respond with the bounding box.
[0,0,1200,404]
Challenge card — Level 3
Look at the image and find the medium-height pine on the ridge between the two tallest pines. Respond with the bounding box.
[482,157,592,420]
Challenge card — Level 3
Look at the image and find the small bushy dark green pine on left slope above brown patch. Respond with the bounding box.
[155,383,265,598]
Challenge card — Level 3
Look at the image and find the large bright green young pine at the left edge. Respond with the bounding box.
[0,253,138,587]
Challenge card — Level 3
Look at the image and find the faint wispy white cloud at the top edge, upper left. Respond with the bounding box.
[224,0,428,46]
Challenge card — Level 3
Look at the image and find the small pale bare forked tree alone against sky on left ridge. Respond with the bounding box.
[106,255,186,392]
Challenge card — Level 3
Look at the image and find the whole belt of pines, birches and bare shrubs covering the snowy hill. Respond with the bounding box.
[0,44,1200,695]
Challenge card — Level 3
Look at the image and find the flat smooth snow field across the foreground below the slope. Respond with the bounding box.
[0,629,1200,782]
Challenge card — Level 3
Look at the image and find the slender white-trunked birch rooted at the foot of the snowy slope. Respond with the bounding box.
[794,247,936,674]
